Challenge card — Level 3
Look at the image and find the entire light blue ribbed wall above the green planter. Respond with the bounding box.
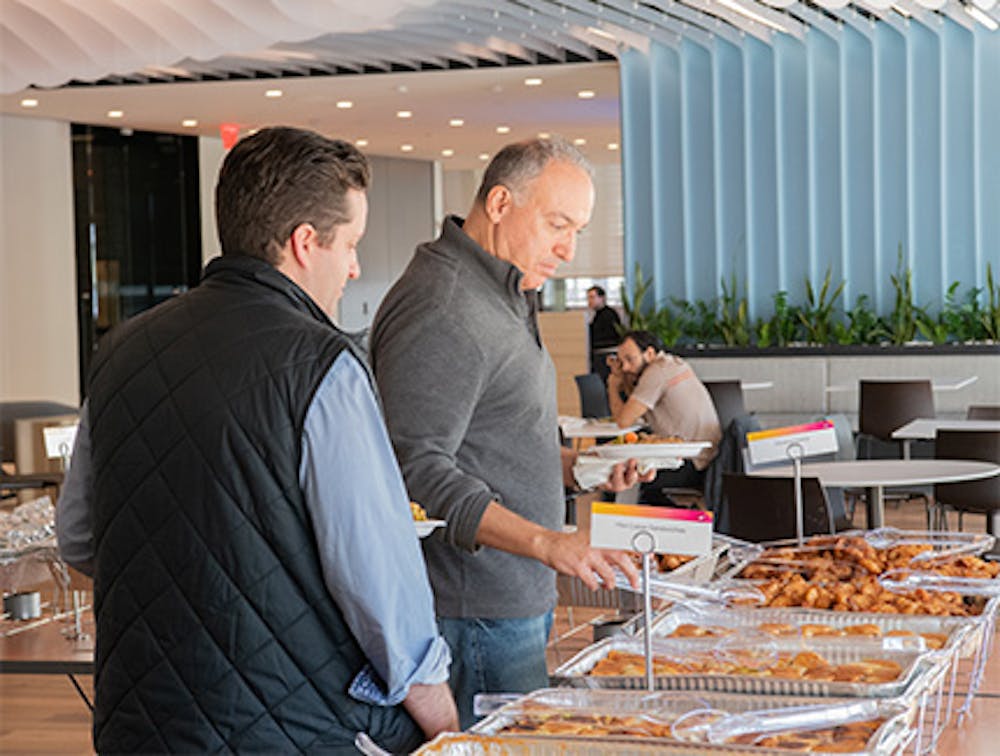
[621,22,1000,317]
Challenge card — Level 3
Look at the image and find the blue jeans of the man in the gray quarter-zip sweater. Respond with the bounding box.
[438,612,552,730]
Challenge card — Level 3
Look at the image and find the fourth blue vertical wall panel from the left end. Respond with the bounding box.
[712,37,755,315]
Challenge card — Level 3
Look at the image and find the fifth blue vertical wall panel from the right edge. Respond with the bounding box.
[840,26,876,307]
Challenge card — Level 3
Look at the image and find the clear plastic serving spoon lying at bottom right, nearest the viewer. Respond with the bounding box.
[671,700,902,744]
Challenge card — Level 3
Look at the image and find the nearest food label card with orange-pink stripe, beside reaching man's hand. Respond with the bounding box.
[590,501,712,556]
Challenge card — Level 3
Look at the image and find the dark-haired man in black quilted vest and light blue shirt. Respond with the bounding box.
[58,128,457,753]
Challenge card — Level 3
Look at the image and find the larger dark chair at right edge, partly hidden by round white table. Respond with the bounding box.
[934,430,1000,535]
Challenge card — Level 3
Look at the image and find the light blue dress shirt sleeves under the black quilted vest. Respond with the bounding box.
[56,352,451,706]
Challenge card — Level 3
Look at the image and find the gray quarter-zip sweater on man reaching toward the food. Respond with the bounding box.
[371,217,564,618]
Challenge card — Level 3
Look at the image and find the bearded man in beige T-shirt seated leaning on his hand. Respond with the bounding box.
[607,331,722,505]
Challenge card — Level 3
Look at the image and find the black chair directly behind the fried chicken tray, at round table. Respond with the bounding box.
[720,473,850,543]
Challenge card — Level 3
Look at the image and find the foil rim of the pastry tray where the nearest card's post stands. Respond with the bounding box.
[549,638,936,698]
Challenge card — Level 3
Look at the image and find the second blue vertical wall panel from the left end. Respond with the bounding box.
[649,42,686,303]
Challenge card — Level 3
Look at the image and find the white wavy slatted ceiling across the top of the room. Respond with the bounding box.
[0,0,1000,93]
